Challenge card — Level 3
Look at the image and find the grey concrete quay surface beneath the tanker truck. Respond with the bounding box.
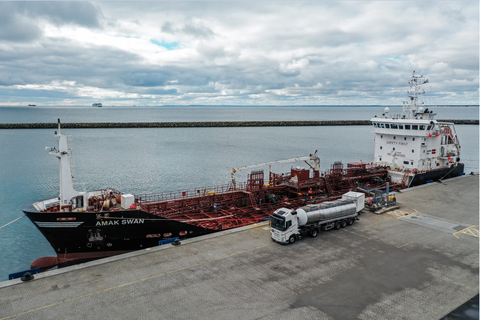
[0,175,479,320]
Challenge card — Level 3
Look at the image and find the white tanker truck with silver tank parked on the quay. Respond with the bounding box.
[270,192,365,244]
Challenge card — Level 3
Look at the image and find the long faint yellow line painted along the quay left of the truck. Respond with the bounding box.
[0,242,274,320]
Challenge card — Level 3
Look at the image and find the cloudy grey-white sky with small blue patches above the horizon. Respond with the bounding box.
[0,1,479,106]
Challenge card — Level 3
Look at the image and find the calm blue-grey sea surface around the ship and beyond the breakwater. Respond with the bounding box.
[0,107,479,281]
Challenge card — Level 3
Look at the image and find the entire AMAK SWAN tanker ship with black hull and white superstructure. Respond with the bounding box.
[23,73,464,268]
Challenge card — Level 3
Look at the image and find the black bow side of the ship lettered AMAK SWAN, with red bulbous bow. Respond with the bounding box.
[23,205,216,268]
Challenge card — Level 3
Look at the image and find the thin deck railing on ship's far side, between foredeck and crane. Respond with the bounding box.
[135,182,246,204]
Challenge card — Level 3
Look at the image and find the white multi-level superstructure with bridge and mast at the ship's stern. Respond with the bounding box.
[371,71,460,182]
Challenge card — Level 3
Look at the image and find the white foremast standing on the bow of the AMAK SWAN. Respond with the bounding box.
[49,119,80,208]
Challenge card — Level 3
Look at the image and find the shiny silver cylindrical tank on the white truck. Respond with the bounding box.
[296,200,357,226]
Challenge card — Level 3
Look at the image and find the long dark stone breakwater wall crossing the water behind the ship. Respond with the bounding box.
[0,120,478,129]
